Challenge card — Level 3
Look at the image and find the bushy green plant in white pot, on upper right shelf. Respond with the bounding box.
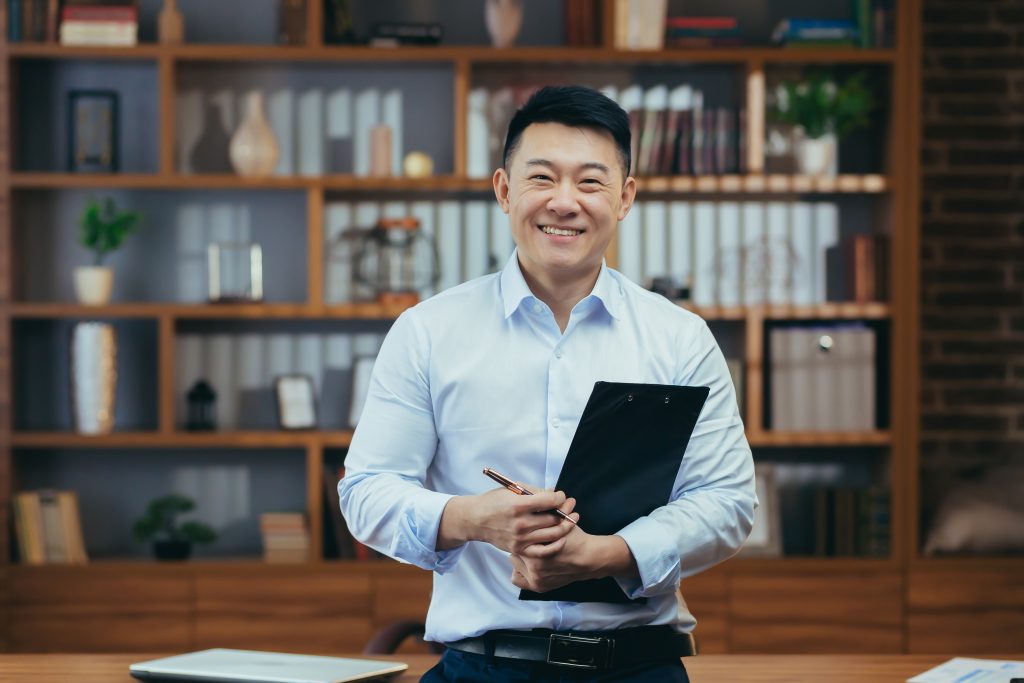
[772,72,874,175]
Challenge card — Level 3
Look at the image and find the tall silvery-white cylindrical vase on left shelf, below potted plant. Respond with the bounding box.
[71,323,118,434]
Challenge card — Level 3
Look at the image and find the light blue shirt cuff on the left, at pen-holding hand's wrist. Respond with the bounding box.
[391,490,465,573]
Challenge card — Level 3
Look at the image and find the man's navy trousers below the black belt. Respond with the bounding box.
[420,648,690,683]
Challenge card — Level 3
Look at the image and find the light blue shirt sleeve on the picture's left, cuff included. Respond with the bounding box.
[338,309,462,573]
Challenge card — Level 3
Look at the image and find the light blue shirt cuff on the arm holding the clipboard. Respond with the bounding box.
[615,517,681,600]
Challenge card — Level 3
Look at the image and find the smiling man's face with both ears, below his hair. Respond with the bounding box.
[494,123,636,285]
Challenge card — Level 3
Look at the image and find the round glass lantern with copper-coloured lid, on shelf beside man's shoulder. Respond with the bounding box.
[353,217,440,306]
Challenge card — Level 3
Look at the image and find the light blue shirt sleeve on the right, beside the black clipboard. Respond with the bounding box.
[617,324,758,599]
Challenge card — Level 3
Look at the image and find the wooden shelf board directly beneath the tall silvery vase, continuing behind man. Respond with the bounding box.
[11,430,892,449]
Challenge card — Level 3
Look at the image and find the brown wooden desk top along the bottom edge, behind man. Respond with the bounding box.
[0,654,1007,683]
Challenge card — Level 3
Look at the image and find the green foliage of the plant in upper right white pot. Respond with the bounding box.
[772,72,874,139]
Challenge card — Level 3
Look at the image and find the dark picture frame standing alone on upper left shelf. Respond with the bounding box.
[68,90,121,173]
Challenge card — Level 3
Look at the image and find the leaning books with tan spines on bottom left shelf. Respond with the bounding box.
[12,488,89,564]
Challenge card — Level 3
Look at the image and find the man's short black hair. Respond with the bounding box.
[502,85,631,179]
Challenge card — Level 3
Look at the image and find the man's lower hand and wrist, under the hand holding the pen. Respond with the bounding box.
[509,528,640,593]
